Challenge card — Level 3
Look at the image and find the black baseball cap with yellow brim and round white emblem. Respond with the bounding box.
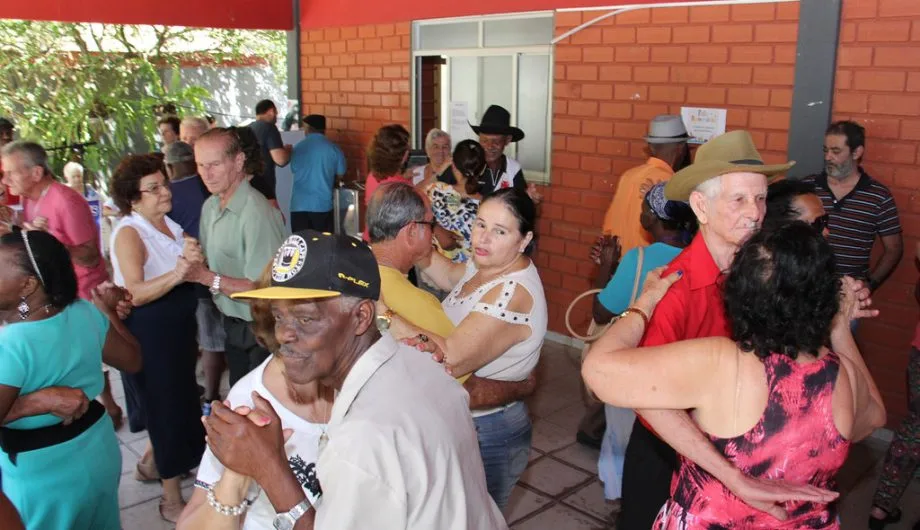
[233,230,380,300]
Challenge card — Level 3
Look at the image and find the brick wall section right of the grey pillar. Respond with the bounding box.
[834,0,920,423]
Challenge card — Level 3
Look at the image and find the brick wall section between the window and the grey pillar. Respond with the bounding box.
[536,3,798,346]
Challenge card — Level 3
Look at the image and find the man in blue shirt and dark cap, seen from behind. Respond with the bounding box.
[291,114,346,232]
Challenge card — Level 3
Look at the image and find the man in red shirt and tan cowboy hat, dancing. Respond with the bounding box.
[617,131,868,530]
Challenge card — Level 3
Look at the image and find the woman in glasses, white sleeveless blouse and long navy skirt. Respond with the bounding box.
[109,155,204,522]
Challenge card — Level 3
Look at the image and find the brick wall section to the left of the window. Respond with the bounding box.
[300,22,411,181]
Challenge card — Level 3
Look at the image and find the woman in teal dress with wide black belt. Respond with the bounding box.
[0,231,141,530]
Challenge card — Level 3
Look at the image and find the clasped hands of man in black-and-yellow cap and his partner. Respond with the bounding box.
[201,392,294,484]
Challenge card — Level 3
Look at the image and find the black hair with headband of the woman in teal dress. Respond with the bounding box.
[0,230,77,309]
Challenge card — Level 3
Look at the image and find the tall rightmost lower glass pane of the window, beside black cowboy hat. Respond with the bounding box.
[517,55,550,176]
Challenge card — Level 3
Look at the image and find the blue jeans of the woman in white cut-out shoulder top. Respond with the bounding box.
[473,401,533,510]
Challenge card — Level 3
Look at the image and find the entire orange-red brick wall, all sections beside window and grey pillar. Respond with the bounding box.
[301,0,920,424]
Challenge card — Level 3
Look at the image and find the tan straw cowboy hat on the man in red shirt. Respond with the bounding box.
[664,131,795,202]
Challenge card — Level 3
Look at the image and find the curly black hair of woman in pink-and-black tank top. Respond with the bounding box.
[723,221,840,359]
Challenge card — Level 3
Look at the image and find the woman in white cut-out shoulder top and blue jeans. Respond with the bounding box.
[416,188,547,508]
